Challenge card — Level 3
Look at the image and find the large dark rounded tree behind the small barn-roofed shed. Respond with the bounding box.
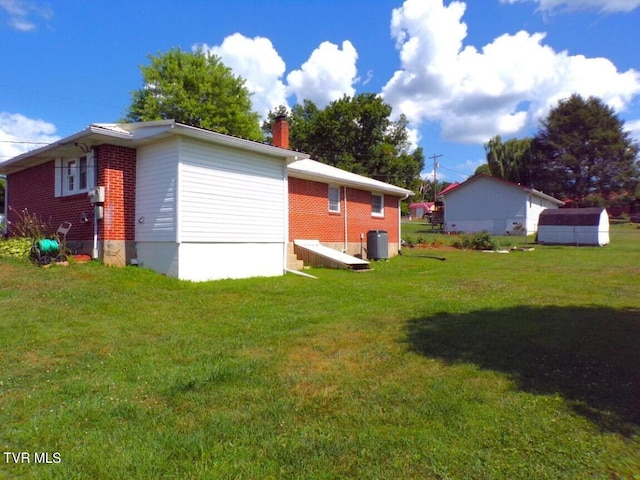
[532,94,640,206]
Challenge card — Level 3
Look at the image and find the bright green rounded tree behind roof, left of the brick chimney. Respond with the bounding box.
[125,48,262,140]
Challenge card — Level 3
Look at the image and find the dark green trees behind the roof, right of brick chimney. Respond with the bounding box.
[263,93,424,191]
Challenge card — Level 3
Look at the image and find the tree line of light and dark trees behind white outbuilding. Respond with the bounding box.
[476,94,640,207]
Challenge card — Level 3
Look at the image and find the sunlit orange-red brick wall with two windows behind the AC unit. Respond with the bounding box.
[289,177,400,251]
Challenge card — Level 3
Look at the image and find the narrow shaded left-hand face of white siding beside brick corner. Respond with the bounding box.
[135,139,178,242]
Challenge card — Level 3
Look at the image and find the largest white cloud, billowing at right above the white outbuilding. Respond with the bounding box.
[382,0,640,143]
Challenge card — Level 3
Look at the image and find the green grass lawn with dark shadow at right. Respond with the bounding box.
[0,225,640,479]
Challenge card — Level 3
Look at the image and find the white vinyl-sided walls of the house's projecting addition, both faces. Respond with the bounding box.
[136,133,287,281]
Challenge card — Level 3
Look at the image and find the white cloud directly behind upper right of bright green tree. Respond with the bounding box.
[196,33,287,118]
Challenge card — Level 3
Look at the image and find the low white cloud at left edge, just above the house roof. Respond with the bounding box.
[0,112,60,162]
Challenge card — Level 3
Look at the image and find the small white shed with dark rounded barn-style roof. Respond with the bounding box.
[538,207,609,246]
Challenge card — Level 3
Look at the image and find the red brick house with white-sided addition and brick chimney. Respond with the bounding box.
[0,120,410,281]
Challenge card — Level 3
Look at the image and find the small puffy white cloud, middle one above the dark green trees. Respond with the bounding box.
[287,40,358,108]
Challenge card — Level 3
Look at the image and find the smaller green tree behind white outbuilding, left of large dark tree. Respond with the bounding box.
[484,135,533,185]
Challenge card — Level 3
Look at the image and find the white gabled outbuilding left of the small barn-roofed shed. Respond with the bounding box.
[441,174,563,235]
